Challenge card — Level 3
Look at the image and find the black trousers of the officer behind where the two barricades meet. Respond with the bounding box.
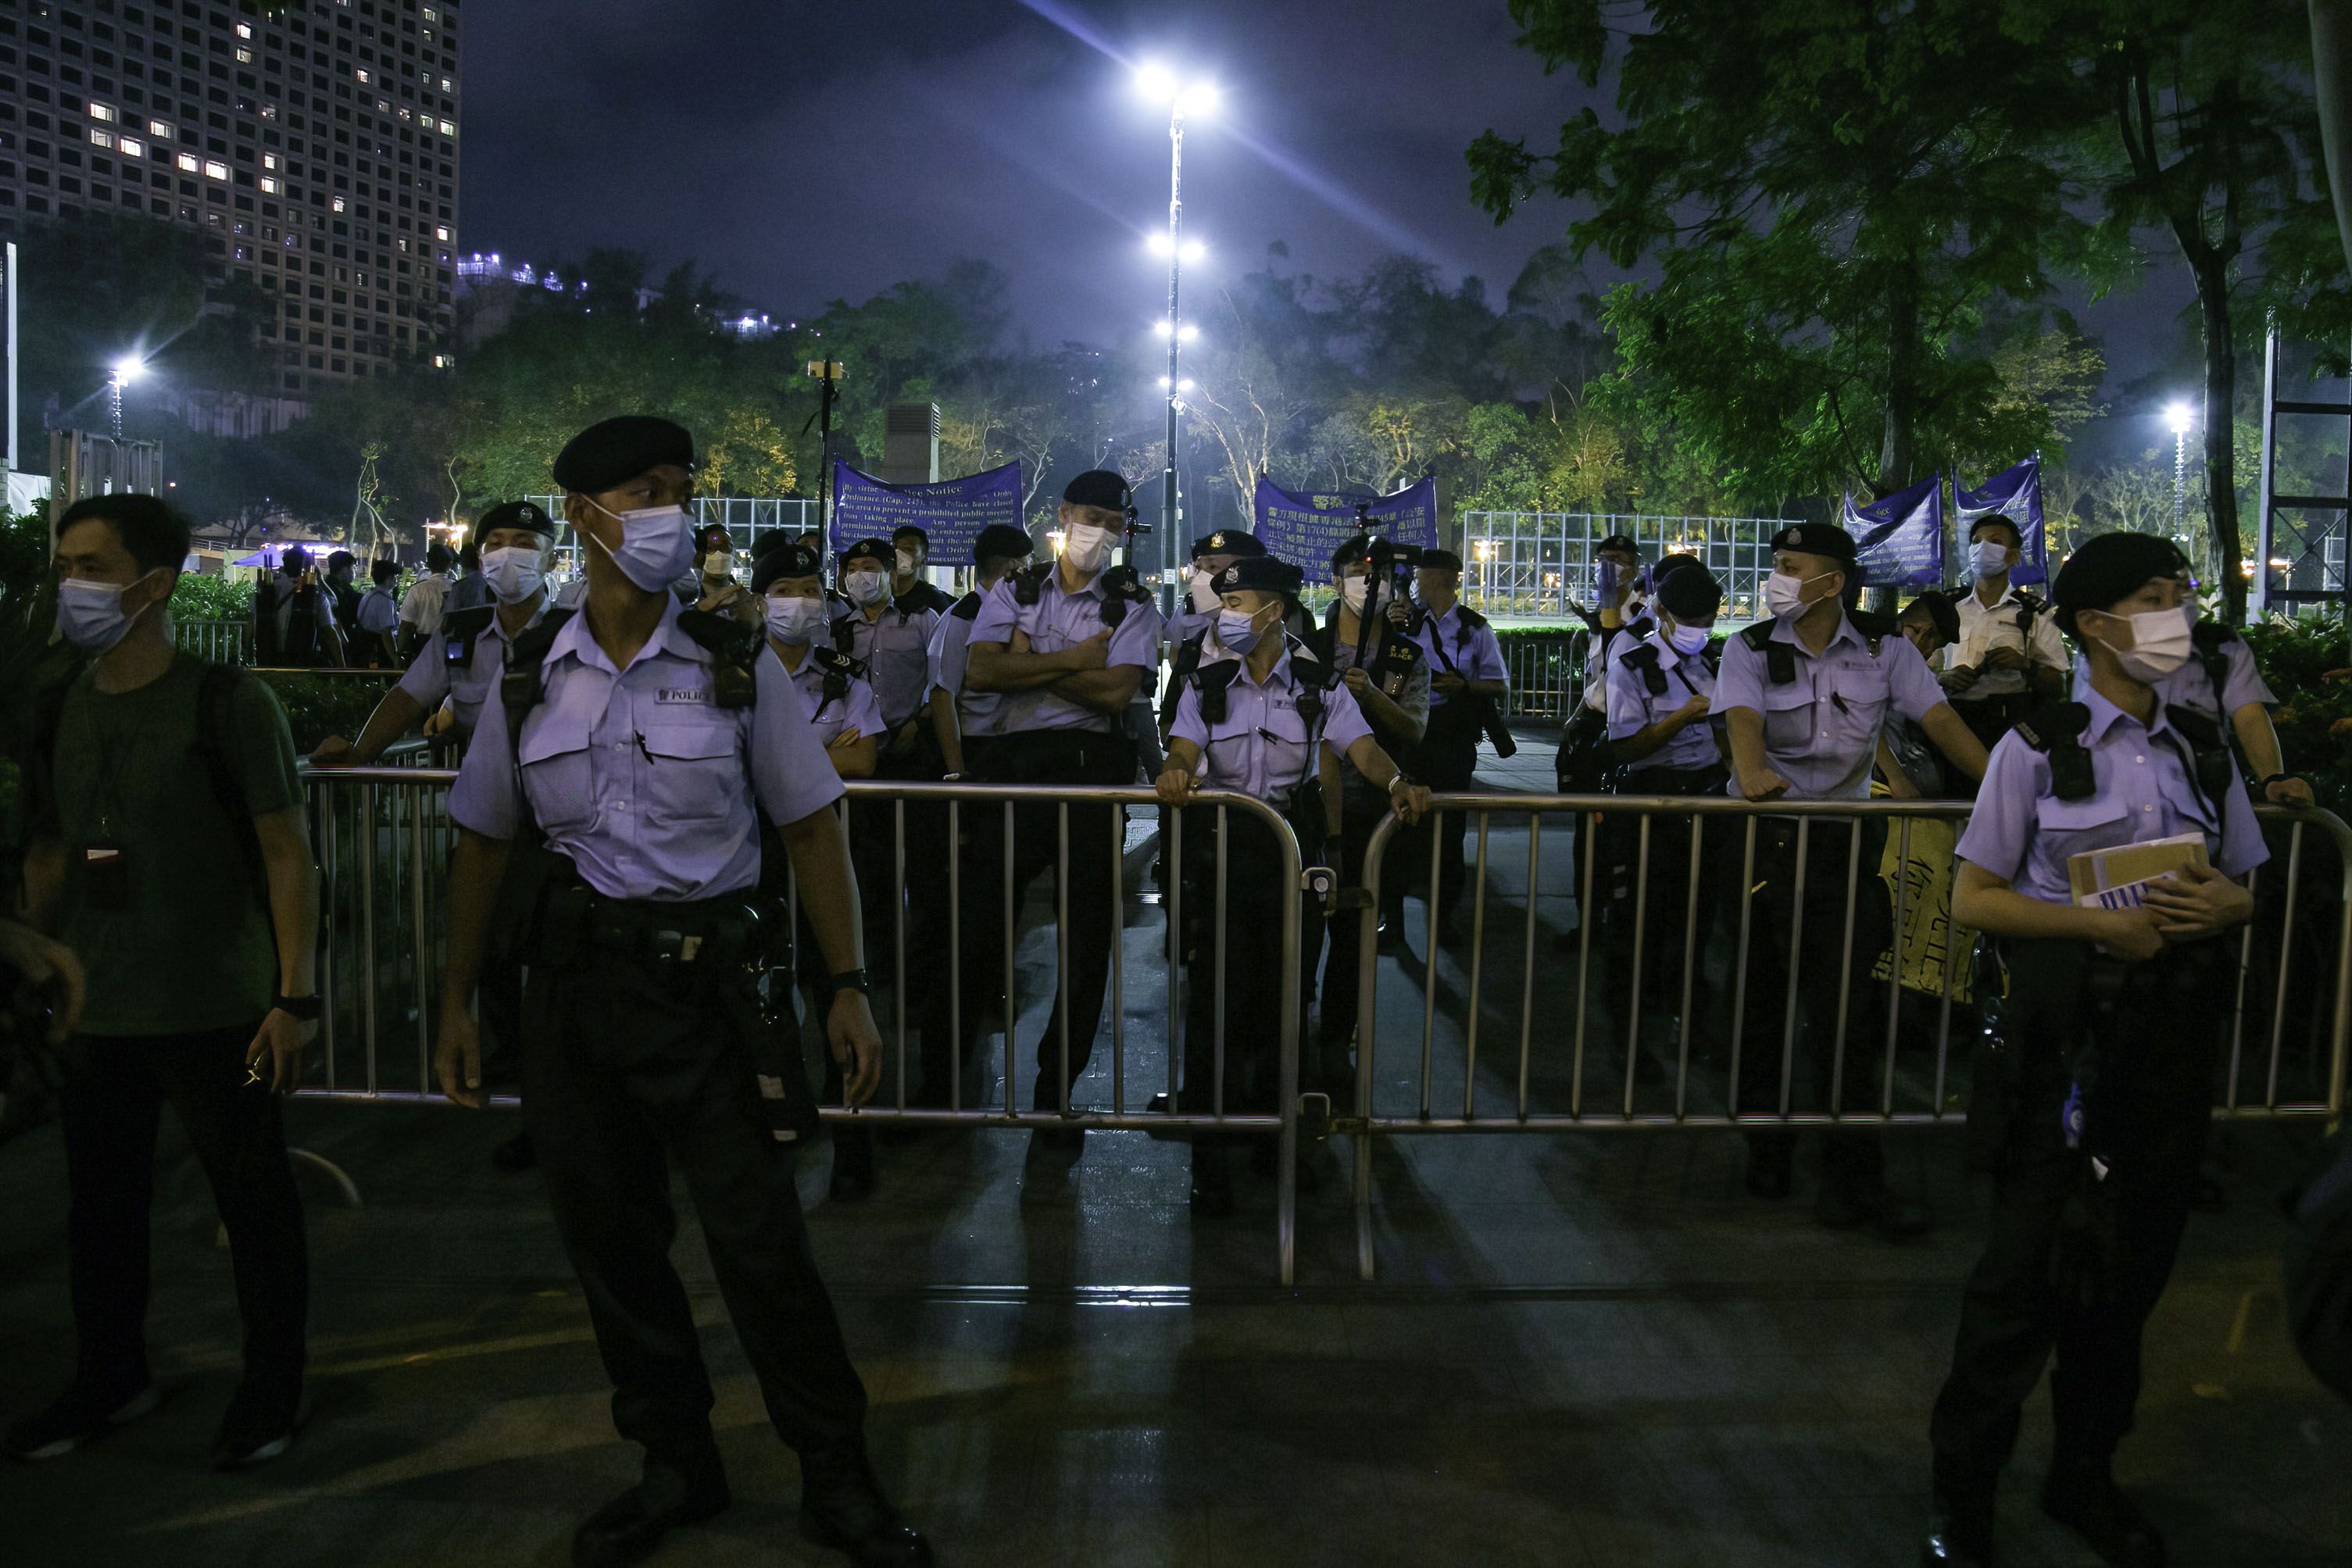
[1178,806,1322,1114]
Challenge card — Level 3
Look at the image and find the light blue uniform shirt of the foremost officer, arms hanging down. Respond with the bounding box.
[449,599,842,902]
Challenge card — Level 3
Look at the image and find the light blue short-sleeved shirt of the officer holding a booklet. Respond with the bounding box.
[1959,691,2270,902]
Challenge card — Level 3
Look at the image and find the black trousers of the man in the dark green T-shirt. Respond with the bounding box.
[61,1020,310,1391]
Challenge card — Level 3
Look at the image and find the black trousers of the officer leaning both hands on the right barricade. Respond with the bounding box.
[1717,816,1893,1183]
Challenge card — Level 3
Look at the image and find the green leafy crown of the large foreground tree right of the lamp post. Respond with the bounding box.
[1470,0,2091,494]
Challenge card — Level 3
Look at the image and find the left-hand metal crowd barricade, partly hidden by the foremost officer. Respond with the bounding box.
[303,766,1303,1284]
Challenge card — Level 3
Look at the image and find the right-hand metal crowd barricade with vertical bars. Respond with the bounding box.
[1331,795,2352,1279]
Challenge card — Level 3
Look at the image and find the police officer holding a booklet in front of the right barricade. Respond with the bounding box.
[1924,534,2265,1563]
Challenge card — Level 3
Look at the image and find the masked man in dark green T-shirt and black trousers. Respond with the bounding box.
[7,494,320,1470]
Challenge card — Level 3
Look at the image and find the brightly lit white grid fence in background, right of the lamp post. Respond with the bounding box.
[1460,513,1788,620]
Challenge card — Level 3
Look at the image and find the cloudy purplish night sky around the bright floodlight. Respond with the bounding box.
[461,0,2187,385]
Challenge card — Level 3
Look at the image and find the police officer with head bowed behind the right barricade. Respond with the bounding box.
[1600,562,1728,1070]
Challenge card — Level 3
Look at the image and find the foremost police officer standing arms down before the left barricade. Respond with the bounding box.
[435,416,931,1563]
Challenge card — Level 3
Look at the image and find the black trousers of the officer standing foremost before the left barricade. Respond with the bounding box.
[522,902,866,1472]
